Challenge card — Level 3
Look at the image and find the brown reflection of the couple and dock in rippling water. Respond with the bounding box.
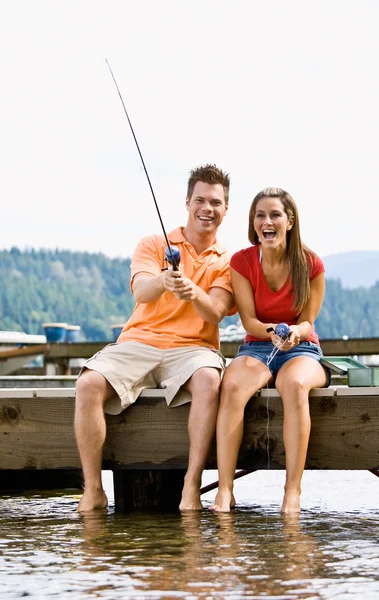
[77,511,327,599]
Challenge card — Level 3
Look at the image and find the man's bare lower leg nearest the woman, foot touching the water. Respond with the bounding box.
[179,367,220,510]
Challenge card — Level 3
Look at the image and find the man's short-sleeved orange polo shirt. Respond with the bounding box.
[118,227,232,350]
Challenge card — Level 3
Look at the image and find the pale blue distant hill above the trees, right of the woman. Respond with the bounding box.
[322,250,379,289]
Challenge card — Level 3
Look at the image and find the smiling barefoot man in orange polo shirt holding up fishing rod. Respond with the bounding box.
[75,165,233,511]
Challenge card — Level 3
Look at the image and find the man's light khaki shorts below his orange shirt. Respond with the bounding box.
[79,342,225,415]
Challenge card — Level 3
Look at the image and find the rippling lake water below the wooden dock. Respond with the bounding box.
[0,471,379,600]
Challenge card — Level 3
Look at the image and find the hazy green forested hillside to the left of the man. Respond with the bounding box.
[0,248,134,341]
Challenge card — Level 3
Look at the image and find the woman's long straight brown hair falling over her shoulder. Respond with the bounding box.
[249,188,314,313]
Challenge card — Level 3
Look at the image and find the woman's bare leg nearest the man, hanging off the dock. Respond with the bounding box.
[211,356,271,512]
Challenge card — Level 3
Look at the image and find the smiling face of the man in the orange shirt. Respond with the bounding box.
[186,181,228,235]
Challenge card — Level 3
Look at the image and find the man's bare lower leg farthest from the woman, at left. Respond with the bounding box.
[75,369,115,512]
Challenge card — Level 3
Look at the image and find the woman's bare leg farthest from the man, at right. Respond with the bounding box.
[276,356,326,513]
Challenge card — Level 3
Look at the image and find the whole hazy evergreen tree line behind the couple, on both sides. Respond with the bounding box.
[0,247,379,341]
